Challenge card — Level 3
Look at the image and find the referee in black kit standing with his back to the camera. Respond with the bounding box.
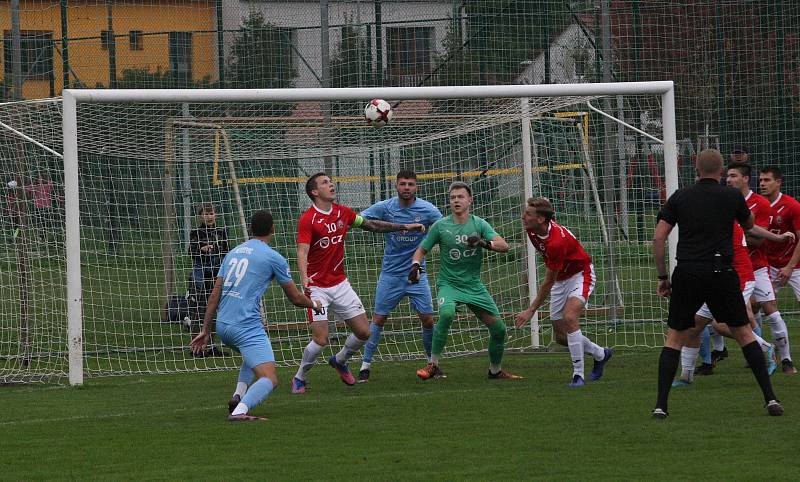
[653,149,783,418]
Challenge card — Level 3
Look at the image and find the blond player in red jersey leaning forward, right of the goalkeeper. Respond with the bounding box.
[514,197,614,387]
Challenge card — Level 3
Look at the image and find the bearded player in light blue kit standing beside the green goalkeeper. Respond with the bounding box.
[358,170,442,383]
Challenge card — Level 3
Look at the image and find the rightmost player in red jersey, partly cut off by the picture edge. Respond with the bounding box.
[759,167,800,375]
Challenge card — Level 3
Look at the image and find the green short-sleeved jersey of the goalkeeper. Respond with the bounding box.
[420,214,497,289]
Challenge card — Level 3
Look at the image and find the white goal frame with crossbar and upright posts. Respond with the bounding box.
[62,81,678,385]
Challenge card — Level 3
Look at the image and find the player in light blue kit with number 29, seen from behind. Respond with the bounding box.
[189,211,322,421]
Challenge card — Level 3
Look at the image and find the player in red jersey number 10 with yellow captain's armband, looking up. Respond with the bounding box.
[292,172,425,393]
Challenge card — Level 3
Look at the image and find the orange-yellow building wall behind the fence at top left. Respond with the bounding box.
[0,0,217,99]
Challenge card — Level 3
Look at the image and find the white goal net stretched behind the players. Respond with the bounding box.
[0,84,674,383]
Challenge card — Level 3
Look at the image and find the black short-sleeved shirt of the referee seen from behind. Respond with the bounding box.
[658,179,750,265]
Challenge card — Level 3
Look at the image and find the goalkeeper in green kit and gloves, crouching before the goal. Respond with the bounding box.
[408,182,522,380]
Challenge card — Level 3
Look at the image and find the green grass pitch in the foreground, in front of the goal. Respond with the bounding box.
[0,336,800,480]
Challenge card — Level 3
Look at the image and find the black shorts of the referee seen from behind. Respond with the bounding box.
[667,264,750,331]
